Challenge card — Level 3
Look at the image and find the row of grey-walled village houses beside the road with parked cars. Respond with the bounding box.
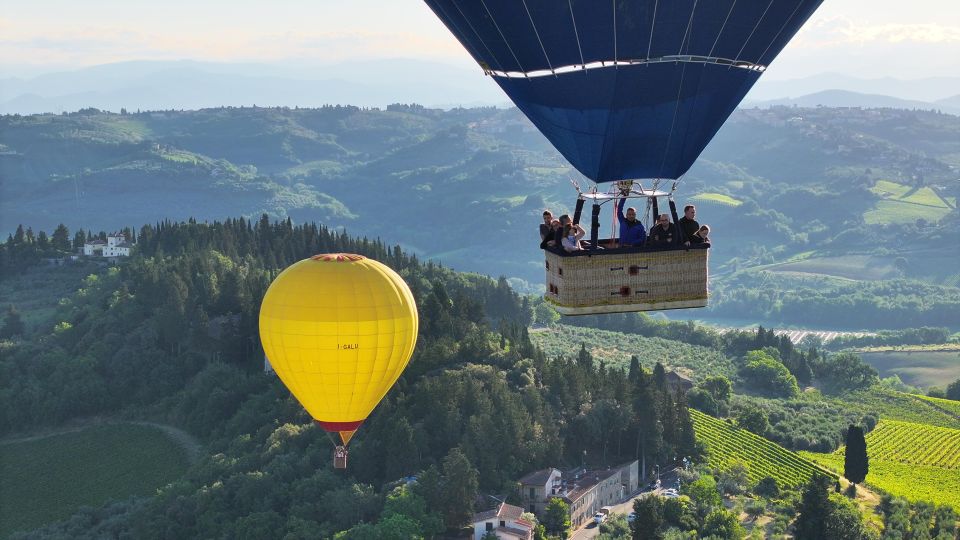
[519,460,640,527]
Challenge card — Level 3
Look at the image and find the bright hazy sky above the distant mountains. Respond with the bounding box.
[0,0,960,79]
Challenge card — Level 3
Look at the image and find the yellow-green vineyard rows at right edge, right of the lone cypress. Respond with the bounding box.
[836,420,960,469]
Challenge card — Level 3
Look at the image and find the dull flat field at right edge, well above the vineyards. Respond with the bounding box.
[859,350,960,388]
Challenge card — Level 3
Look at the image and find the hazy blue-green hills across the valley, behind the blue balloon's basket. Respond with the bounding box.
[0,105,960,306]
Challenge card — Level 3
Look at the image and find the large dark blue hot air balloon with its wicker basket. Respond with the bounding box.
[425,0,822,314]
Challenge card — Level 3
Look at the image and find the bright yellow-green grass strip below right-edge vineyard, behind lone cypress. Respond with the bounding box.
[800,452,960,510]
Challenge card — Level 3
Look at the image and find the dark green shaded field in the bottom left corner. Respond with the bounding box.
[0,424,188,538]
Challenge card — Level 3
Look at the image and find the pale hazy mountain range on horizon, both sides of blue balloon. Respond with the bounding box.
[0,59,960,114]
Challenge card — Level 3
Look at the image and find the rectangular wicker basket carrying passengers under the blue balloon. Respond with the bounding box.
[544,245,710,315]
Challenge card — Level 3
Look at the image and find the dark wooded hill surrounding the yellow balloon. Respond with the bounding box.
[0,217,698,538]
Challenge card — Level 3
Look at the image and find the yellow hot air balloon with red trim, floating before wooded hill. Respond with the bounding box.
[260,253,419,466]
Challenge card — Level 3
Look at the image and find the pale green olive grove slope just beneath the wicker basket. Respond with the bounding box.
[530,325,736,380]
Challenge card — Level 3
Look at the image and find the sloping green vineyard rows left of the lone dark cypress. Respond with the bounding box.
[690,409,835,487]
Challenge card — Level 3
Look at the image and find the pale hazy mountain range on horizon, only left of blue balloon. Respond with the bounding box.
[0,59,508,114]
